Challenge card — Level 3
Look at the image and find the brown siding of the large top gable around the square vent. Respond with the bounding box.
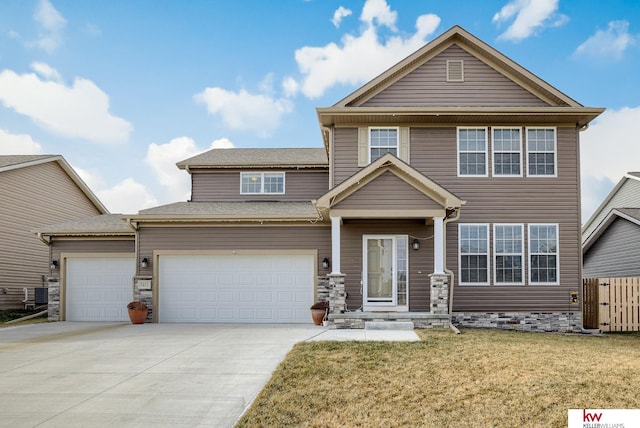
[362,45,549,107]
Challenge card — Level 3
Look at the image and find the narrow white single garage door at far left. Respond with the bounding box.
[66,257,136,321]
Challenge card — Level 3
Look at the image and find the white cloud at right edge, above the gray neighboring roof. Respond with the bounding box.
[580,107,640,219]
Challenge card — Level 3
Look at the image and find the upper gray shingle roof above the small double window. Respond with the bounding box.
[176,148,329,169]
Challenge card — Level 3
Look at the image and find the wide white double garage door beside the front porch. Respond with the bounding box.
[158,255,314,323]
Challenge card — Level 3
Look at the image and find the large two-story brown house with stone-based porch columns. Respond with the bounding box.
[36,26,603,331]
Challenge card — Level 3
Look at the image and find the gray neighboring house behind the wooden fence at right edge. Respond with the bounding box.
[582,172,640,278]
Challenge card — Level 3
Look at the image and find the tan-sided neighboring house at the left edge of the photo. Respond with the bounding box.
[0,155,107,309]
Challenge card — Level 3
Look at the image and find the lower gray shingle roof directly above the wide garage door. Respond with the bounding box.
[139,201,318,220]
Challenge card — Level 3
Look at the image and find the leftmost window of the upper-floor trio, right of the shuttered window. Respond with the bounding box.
[458,127,488,177]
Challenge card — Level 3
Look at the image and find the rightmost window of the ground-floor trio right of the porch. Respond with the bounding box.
[529,224,560,285]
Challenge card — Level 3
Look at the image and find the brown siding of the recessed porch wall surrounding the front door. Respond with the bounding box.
[340,219,433,311]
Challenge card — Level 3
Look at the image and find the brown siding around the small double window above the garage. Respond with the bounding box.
[191,170,329,202]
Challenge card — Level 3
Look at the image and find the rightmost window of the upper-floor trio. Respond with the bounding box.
[527,127,558,177]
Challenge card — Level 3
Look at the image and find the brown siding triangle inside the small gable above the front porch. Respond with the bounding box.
[334,172,442,210]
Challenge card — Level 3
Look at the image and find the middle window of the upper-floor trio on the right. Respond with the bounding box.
[491,127,522,177]
